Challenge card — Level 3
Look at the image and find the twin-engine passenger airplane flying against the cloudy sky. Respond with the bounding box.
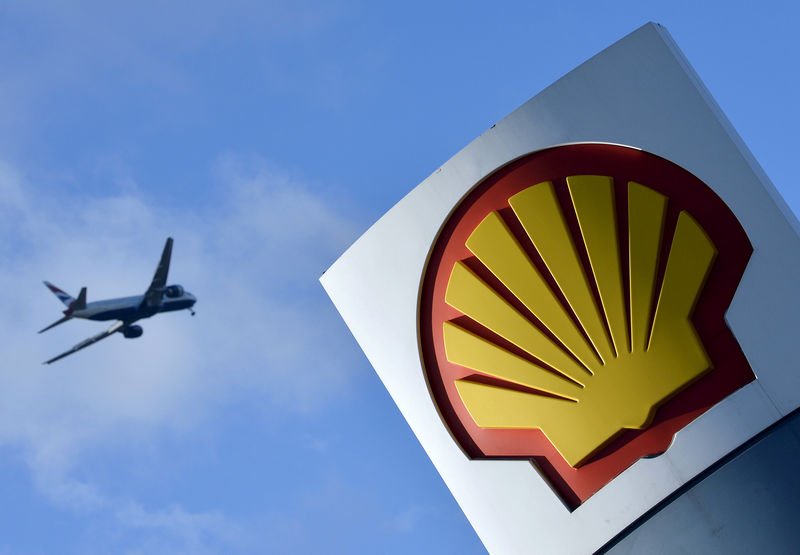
[39,237,197,364]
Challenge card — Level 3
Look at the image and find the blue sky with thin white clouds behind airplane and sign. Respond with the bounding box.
[0,0,800,554]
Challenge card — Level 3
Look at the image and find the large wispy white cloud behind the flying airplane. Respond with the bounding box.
[0,157,356,552]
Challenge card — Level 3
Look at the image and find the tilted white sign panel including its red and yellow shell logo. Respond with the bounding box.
[321,24,800,553]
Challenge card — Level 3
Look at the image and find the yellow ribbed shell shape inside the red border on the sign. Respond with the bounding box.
[444,175,716,467]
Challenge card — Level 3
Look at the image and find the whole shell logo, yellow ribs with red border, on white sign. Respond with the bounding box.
[419,144,755,509]
